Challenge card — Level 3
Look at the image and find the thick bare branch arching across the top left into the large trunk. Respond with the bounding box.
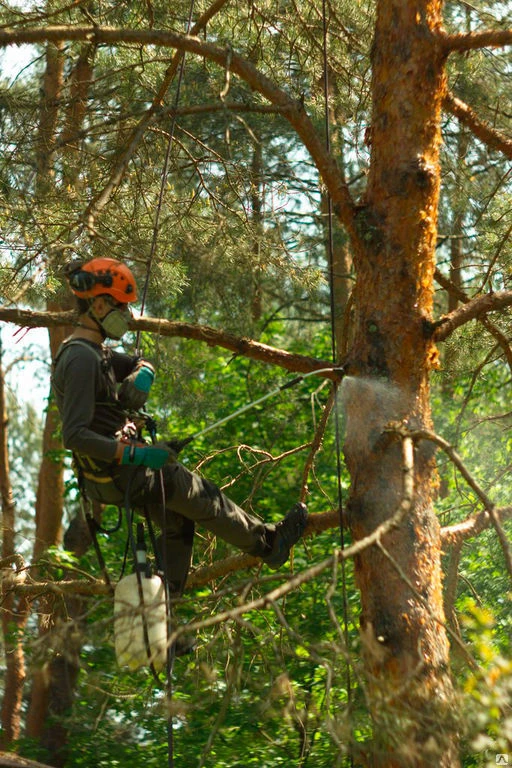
[0,25,359,240]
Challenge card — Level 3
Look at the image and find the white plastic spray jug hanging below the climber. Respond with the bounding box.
[114,573,167,671]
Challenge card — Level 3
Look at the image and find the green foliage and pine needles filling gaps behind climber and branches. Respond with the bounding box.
[0,0,512,768]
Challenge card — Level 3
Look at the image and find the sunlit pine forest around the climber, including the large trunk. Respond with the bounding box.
[0,0,512,768]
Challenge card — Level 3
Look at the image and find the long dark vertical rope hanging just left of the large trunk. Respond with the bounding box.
[322,0,354,767]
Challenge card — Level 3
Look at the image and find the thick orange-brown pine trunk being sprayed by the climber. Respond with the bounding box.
[345,0,458,768]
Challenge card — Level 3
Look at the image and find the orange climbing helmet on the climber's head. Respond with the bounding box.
[68,258,137,304]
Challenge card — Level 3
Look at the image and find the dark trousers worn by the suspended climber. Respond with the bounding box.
[85,462,274,594]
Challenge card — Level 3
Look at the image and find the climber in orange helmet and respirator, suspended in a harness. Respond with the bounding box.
[52,258,307,595]
